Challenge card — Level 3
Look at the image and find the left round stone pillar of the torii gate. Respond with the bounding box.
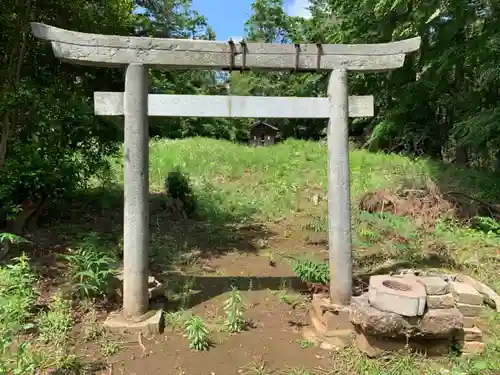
[123,64,149,318]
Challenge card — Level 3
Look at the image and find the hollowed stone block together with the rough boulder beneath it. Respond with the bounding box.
[350,276,463,357]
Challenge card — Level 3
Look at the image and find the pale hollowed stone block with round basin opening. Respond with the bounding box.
[368,275,427,316]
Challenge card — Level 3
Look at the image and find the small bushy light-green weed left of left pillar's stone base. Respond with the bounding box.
[36,294,73,346]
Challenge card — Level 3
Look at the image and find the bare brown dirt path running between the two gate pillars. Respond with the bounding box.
[100,232,330,375]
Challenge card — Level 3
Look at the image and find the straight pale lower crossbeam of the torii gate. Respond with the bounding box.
[94,92,374,118]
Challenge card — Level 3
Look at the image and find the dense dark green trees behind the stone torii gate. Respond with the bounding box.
[0,0,500,236]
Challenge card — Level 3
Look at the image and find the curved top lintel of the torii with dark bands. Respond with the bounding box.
[31,22,421,72]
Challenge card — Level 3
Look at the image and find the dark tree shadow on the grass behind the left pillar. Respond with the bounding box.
[29,185,272,271]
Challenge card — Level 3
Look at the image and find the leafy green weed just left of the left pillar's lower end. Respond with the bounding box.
[62,235,117,299]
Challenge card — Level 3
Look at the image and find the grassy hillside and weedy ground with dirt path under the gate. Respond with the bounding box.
[0,138,500,375]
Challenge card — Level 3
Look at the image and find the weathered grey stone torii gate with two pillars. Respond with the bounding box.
[31,23,420,320]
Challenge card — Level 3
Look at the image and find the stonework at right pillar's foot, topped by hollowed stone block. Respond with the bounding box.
[304,275,490,357]
